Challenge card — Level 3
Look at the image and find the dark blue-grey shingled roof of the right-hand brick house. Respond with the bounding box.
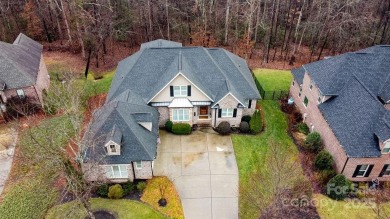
[300,46,390,157]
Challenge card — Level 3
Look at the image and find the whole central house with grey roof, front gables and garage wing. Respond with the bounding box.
[83,40,260,181]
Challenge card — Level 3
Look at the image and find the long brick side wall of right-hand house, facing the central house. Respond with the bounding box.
[290,74,347,172]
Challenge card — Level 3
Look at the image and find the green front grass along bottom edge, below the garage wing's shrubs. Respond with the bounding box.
[46,198,165,219]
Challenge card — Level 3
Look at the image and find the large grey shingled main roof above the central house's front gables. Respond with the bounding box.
[107,41,260,106]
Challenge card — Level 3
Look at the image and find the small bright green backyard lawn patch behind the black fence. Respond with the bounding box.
[253,68,292,91]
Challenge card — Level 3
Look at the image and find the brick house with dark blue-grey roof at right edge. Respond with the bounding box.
[290,45,390,181]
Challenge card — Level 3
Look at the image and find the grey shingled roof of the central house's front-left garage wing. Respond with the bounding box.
[83,90,159,164]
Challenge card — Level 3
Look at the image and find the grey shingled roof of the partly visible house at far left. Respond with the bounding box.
[0,33,42,89]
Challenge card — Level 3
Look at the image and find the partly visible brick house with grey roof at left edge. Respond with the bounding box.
[0,33,50,112]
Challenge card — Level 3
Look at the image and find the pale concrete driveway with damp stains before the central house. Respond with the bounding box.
[154,129,238,219]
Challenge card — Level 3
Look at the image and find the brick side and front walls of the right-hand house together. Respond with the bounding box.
[290,73,390,181]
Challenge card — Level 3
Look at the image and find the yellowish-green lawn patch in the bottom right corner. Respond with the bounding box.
[313,194,390,219]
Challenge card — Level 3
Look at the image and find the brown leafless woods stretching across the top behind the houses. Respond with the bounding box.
[0,0,390,68]
